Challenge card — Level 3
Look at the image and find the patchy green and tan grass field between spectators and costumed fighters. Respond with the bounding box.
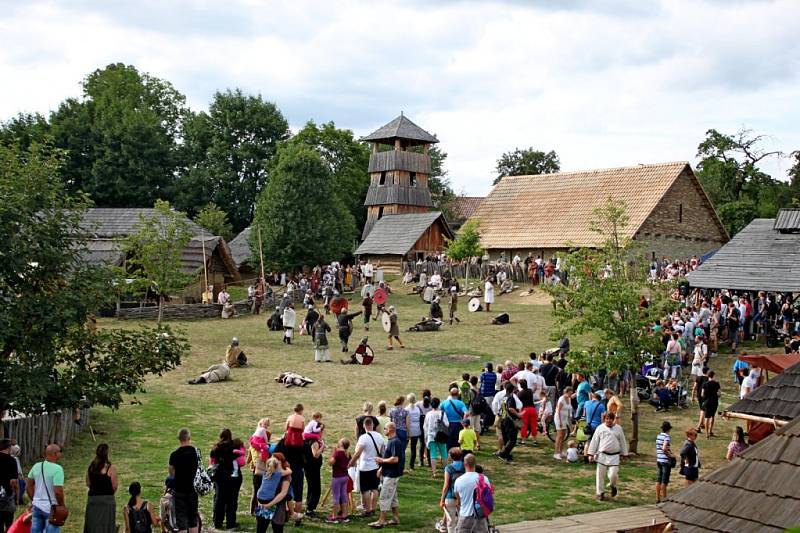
[32,280,756,531]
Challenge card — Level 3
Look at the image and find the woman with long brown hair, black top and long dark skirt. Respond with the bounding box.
[83,443,117,533]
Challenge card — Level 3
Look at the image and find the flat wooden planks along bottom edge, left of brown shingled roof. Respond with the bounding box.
[497,505,668,533]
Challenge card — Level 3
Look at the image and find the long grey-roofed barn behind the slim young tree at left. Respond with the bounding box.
[83,208,239,301]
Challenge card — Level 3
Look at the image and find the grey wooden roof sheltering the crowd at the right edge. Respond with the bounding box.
[686,218,800,292]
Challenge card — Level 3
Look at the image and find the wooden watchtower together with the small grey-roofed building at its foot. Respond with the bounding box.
[356,114,453,273]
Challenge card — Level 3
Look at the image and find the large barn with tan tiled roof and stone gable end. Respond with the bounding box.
[472,162,728,259]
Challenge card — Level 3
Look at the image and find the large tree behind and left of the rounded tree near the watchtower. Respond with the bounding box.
[174,89,289,232]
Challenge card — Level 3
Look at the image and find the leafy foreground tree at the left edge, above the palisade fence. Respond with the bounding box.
[0,142,188,414]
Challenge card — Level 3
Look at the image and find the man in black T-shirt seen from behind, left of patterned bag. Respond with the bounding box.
[169,428,200,533]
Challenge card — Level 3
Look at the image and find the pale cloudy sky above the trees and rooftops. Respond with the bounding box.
[0,0,800,195]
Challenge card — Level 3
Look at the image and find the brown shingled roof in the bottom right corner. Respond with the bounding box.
[659,418,800,533]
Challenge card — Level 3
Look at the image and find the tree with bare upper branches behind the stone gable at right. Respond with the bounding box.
[697,129,793,235]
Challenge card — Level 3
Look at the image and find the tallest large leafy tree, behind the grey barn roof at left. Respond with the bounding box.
[50,63,187,207]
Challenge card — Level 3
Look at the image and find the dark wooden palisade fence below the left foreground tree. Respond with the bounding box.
[2,406,89,464]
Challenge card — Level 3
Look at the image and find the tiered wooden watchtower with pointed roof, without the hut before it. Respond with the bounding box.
[361,113,439,240]
